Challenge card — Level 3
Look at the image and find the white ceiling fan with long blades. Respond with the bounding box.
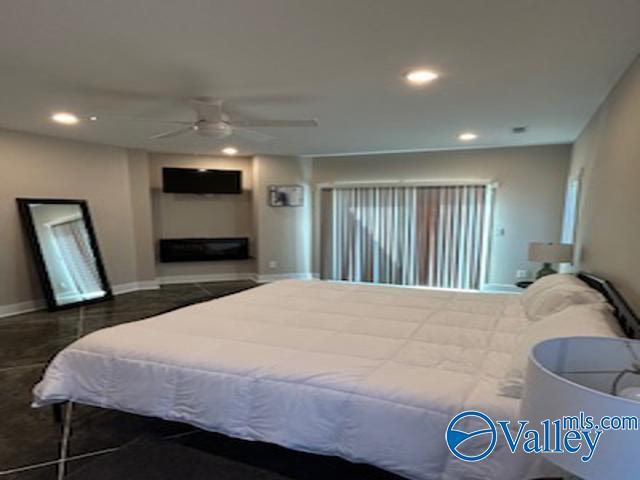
[150,97,318,141]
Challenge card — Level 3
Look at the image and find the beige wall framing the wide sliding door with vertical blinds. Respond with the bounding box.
[312,145,570,285]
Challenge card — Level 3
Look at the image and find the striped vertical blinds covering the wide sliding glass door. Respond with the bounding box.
[321,185,490,289]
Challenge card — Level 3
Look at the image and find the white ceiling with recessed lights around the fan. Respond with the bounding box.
[0,0,640,154]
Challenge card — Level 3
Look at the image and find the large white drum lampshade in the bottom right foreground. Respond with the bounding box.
[520,337,640,480]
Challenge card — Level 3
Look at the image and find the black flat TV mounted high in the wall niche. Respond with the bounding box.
[162,168,242,194]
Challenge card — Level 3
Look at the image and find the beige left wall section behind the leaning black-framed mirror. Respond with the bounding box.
[0,130,137,314]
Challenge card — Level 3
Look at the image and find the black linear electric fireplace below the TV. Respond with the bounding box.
[160,237,249,262]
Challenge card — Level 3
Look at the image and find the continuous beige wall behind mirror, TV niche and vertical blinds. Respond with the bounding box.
[0,127,579,313]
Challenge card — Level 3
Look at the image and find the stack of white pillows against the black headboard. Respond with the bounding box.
[499,274,624,398]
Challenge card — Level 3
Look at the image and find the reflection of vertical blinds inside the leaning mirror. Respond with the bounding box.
[51,219,102,296]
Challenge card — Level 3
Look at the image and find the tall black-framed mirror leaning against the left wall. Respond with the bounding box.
[17,198,113,310]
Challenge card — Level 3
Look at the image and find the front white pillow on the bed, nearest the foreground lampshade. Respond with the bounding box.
[498,304,624,398]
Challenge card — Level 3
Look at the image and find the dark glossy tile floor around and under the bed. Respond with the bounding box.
[0,281,399,480]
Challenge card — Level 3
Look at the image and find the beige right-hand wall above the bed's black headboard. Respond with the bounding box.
[570,58,640,312]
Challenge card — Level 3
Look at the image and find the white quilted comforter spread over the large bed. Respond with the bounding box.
[34,280,544,480]
